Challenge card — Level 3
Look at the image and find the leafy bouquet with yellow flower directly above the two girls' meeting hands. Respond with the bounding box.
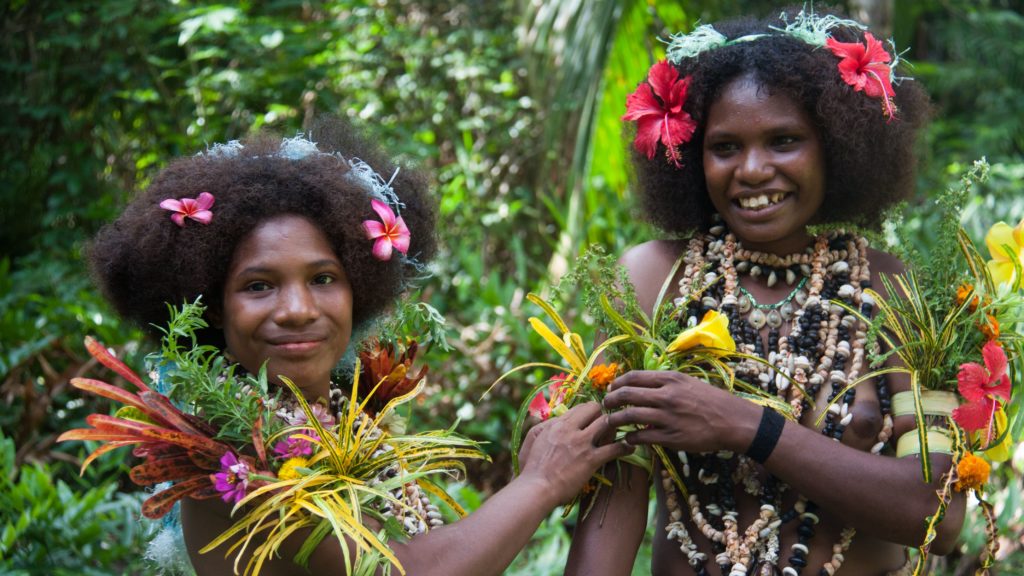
[495,247,803,513]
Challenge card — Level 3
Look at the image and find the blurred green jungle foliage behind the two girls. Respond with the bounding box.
[0,0,1024,575]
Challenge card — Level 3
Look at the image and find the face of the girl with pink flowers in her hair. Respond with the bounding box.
[221,215,352,400]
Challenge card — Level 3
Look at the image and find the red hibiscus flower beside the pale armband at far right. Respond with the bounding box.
[953,341,1010,443]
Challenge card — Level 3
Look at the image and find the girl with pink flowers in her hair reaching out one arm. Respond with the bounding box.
[81,117,630,576]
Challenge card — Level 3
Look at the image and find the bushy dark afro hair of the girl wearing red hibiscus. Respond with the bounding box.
[633,11,931,235]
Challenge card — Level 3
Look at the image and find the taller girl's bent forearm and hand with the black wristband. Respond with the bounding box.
[604,371,964,554]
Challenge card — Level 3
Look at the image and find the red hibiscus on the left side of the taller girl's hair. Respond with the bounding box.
[623,60,697,168]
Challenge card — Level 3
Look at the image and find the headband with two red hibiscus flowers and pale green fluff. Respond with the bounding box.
[623,9,899,168]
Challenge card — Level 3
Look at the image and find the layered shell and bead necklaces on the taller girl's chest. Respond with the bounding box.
[662,224,892,576]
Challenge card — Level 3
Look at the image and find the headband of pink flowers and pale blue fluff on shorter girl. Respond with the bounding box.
[160,133,419,268]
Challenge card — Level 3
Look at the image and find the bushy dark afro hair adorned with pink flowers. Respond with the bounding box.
[88,119,436,347]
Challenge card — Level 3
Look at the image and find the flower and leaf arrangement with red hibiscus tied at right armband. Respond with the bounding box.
[851,161,1024,573]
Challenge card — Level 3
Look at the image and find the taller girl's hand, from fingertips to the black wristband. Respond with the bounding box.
[604,370,761,452]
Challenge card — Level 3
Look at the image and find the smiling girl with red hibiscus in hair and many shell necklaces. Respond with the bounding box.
[566,10,965,576]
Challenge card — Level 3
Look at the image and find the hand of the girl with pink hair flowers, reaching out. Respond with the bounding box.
[519,402,633,505]
